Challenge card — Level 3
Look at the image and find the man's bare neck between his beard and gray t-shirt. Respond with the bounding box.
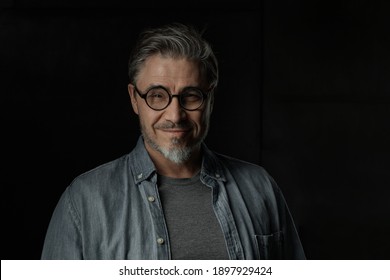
[145,141,202,178]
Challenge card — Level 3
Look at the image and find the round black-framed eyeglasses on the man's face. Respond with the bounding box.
[134,85,207,111]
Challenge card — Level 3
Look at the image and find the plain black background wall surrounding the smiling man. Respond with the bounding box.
[0,0,390,259]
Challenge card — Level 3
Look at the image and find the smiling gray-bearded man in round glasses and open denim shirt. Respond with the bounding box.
[42,24,305,259]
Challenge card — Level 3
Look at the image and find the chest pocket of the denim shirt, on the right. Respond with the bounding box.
[255,231,283,260]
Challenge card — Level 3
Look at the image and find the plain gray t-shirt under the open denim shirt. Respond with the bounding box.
[158,174,229,260]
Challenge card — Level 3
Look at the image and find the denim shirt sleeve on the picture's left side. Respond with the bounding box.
[41,187,83,260]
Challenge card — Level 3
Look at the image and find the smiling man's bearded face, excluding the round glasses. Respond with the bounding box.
[129,55,212,164]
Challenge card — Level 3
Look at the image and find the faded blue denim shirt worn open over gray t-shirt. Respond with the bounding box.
[41,137,305,260]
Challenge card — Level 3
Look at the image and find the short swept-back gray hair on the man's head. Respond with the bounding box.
[128,23,218,90]
